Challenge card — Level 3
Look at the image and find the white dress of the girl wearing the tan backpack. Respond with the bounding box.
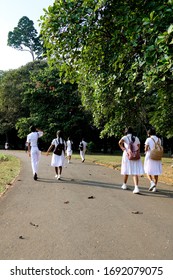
[144,135,162,175]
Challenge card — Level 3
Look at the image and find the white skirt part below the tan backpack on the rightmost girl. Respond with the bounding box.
[144,151,162,175]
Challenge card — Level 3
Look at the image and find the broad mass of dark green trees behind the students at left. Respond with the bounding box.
[0,60,95,149]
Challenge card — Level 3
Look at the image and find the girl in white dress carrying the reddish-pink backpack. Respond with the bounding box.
[119,127,144,194]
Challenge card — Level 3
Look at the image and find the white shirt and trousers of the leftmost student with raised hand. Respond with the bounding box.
[27,131,43,175]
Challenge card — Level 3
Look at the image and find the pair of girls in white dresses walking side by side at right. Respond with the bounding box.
[119,127,162,194]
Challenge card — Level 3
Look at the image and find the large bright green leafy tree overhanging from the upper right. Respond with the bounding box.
[41,0,173,137]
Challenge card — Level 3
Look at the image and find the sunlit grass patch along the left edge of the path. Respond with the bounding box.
[0,153,20,195]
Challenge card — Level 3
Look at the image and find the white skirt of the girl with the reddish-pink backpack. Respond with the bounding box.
[121,151,144,175]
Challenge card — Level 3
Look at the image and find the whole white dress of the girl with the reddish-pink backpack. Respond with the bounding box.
[121,134,144,175]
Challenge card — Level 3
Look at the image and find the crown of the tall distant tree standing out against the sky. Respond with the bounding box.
[7,16,43,60]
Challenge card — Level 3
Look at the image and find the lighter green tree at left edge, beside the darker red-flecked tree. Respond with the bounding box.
[0,61,47,137]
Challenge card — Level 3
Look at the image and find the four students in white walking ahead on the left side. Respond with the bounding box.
[26,126,87,180]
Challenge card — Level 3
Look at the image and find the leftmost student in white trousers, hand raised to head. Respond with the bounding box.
[26,125,43,180]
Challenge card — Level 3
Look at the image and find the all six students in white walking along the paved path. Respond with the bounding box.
[27,126,162,194]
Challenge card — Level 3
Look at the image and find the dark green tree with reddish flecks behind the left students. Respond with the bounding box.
[16,67,94,142]
